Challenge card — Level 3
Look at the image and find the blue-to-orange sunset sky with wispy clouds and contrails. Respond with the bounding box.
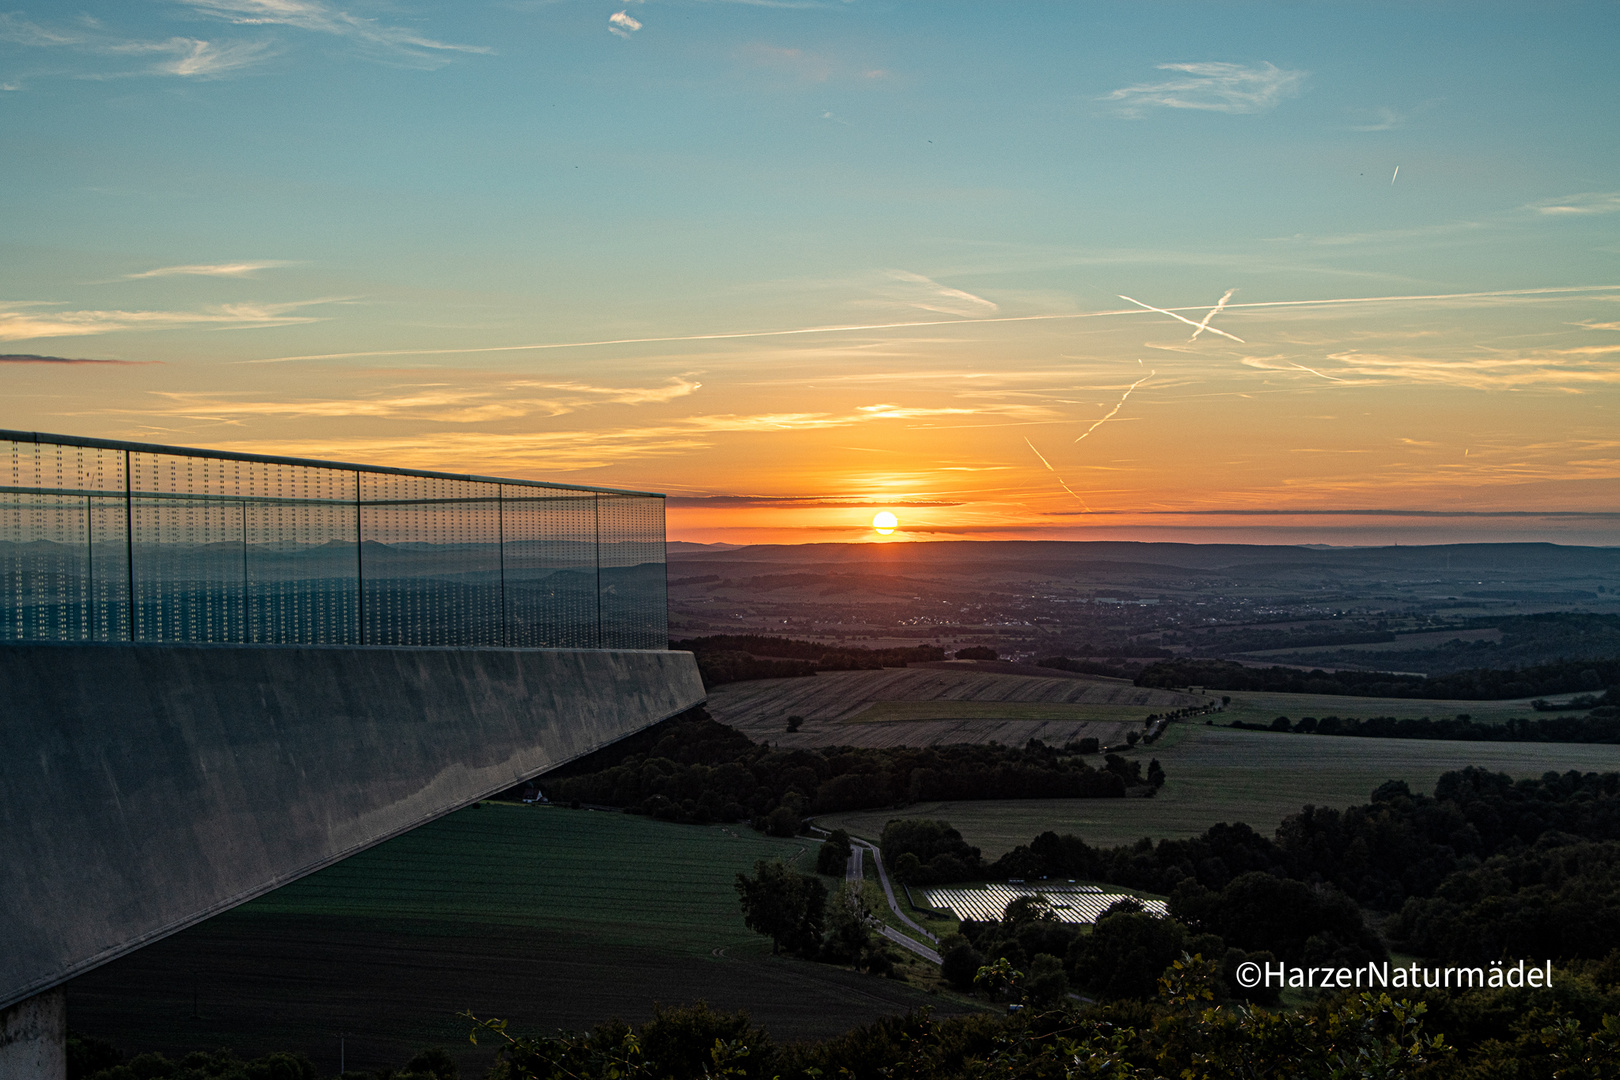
[0,0,1620,544]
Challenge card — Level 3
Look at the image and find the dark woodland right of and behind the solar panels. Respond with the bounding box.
[985,767,1620,962]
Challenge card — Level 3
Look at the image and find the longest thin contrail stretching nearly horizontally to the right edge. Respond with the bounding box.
[233,285,1620,364]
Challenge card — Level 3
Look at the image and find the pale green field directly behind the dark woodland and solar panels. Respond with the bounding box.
[818,712,1620,858]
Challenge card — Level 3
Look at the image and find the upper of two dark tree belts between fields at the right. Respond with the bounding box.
[1136,656,1620,701]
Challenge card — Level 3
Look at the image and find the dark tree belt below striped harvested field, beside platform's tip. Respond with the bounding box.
[546,709,1163,836]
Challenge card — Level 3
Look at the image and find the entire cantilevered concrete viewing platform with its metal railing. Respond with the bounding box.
[0,431,703,1078]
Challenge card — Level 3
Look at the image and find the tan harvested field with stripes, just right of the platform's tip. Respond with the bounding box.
[708,665,1209,746]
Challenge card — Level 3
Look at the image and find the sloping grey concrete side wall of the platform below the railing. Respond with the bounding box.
[0,644,703,1007]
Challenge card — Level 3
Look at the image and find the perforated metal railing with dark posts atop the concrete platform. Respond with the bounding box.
[0,431,669,649]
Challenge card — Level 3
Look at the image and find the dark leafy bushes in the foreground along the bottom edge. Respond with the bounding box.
[440,955,1620,1080]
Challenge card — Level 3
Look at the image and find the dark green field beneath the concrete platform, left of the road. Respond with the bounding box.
[68,805,951,1074]
